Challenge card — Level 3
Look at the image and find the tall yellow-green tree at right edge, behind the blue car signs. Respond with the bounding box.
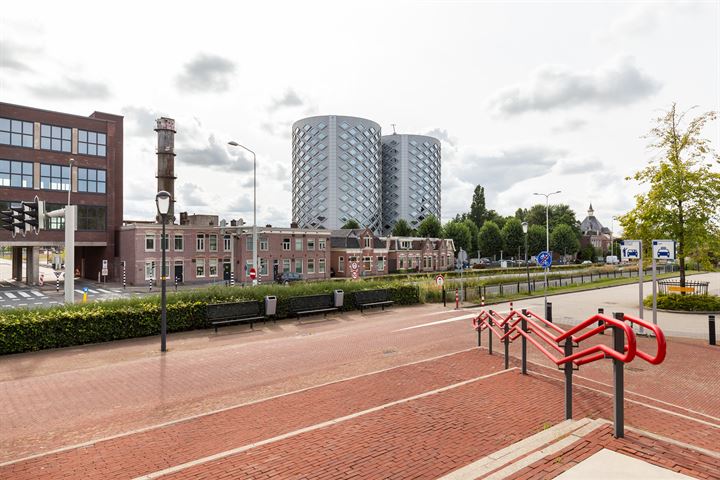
[620,103,720,286]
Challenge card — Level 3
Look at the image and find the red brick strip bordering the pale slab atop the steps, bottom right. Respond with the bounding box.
[508,425,720,480]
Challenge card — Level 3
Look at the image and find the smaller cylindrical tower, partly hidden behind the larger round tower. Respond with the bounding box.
[382,134,441,235]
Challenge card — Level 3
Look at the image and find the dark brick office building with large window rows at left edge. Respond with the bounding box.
[0,102,123,284]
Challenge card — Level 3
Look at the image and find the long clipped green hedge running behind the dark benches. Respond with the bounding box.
[0,282,420,355]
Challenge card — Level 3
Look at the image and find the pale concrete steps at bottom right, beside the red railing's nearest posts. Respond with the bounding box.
[442,418,607,480]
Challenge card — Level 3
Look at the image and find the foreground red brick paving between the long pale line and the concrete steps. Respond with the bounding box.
[0,350,720,479]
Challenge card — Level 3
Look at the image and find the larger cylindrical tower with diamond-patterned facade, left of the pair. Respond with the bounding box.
[292,115,382,233]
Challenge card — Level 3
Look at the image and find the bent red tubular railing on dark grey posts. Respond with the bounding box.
[472,304,667,437]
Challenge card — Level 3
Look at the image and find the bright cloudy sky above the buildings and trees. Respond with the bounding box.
[0,0,720,229]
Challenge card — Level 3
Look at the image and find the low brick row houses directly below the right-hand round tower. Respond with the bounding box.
[387,237,455,273]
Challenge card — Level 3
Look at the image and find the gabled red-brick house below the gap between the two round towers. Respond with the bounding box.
[330,228,388,278]
